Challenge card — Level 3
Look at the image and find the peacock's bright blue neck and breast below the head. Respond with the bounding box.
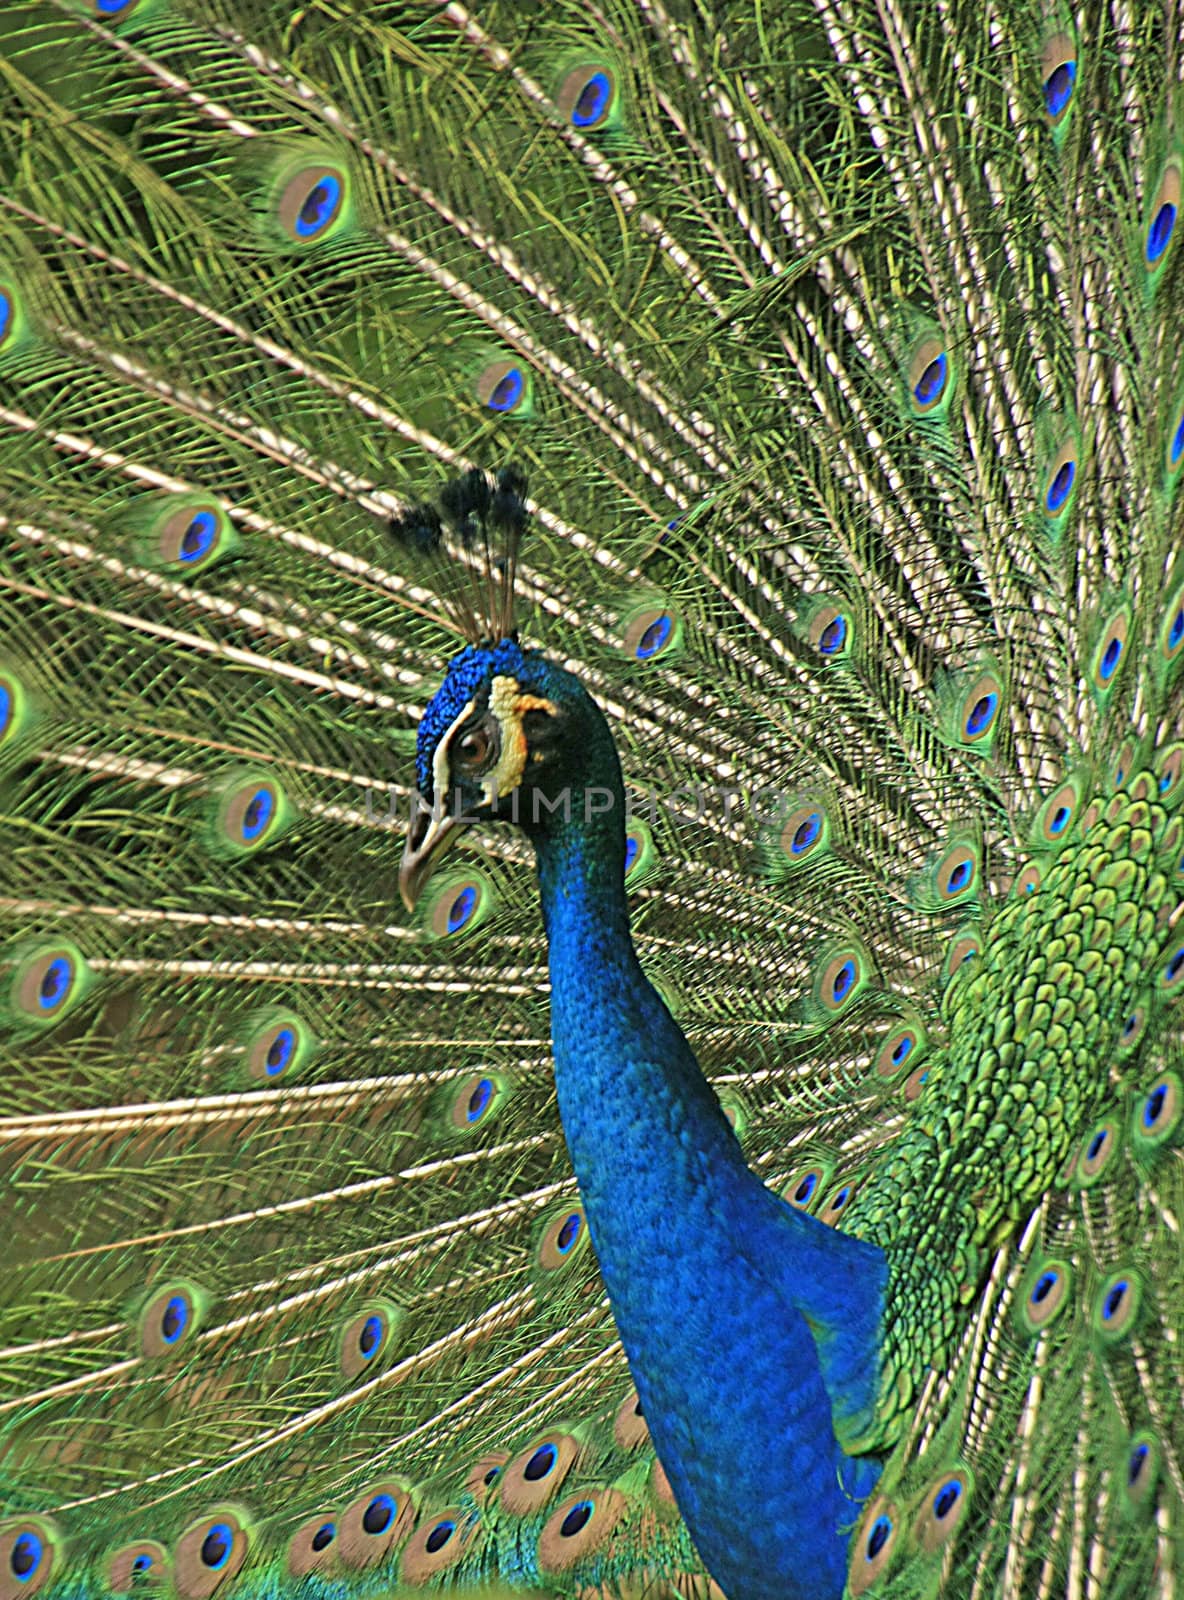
[534,793,886,1600]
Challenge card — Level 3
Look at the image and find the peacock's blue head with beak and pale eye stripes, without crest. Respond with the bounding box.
[398,638,624,910]
